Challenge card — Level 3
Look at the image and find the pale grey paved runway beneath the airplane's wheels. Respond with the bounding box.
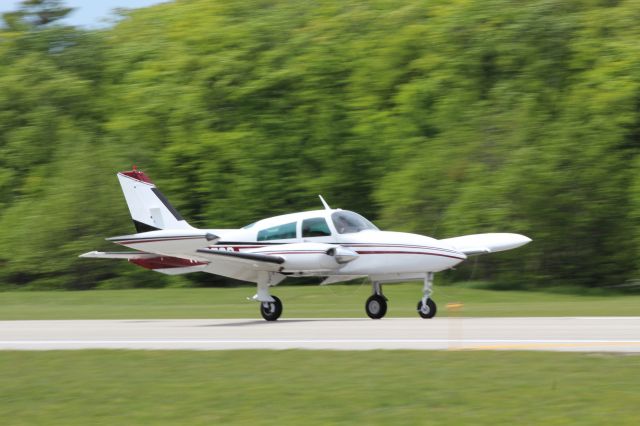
[0,317,640,353]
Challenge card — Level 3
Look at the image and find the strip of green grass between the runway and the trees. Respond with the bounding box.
[0,283,640,320]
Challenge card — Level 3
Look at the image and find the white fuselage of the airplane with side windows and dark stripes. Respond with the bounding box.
[111,209,466,280]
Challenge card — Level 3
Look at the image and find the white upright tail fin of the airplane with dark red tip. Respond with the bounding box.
[118,166,191,232]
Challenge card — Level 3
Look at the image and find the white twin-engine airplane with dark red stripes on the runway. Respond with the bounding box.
[80,167,531,321]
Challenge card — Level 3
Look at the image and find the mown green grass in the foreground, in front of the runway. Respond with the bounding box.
[0,351,640,425]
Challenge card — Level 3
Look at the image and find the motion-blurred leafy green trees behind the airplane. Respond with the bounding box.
[0,0,640,288]
